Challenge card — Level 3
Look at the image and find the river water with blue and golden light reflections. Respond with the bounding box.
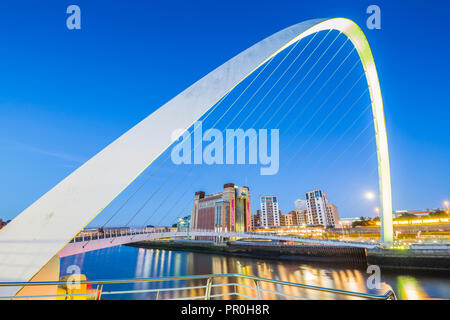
[61,246,450,299]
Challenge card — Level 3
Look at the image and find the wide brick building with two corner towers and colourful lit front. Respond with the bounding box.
[191,183,251,232]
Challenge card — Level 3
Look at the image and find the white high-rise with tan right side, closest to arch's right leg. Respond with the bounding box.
[306,190,339,227]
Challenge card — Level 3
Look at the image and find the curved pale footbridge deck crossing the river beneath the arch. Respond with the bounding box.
[58,230,378,257]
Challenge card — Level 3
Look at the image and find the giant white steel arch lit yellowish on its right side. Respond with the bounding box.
[0,18,393,294]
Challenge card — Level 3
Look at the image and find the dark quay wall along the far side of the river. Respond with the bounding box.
[128,240,450,271]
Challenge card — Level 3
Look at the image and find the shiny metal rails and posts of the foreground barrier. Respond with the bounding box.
[0,273,397,300]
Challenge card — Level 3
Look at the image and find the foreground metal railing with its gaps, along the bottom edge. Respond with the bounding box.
[0,273,397,300]
